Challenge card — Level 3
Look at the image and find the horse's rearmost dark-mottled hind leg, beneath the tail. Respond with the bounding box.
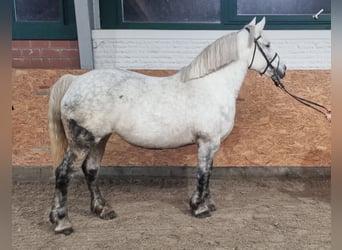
[50,120,95,235]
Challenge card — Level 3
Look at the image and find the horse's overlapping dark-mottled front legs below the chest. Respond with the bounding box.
[190,140,220,218]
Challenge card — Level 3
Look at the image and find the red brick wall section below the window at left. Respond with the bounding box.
[12,40,80,69]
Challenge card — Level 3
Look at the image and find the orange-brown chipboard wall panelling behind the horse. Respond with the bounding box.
[12,69,331,167]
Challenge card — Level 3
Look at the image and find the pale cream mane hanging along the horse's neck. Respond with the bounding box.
[180,32,238,82]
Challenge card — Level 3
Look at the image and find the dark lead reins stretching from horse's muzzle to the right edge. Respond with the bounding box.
[272,74,331,122]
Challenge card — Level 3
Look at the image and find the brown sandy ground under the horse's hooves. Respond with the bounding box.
[12,177,331,250]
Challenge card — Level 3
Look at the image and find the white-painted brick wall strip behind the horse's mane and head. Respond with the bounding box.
[92,30,331,69]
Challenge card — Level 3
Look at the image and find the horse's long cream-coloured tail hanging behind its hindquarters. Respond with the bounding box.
[48,74,76,169]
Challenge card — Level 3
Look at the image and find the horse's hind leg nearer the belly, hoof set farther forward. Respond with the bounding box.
[82,135,116,220]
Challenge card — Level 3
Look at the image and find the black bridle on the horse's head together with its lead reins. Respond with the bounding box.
[245,27,331,121]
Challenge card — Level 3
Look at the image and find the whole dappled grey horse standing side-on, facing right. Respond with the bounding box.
[49,18,286,234]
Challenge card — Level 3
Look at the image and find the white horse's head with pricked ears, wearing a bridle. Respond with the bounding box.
[245,17,286,81]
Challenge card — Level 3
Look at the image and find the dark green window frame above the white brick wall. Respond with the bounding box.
[100,0,331,30]
